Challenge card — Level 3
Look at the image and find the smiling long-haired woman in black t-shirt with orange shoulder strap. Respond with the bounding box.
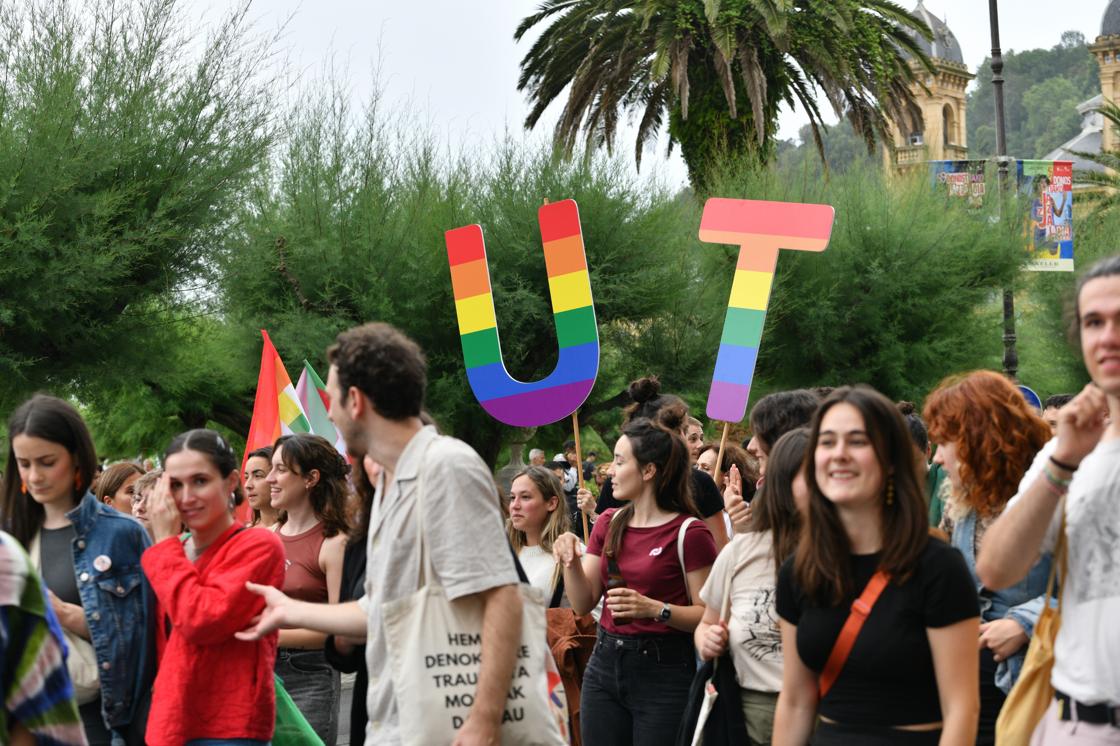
[774,386,980,746]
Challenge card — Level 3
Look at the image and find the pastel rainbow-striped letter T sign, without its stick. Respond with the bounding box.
[700,197,836,422]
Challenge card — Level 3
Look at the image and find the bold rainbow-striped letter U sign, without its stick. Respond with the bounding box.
[445,199,599,427]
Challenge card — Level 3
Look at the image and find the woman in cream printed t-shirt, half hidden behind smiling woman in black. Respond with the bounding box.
[694,428,809,744]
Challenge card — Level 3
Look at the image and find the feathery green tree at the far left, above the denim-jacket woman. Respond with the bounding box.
[0,0,271,422]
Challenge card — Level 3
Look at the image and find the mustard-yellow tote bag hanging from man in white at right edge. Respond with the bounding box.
[996,497,1068,746]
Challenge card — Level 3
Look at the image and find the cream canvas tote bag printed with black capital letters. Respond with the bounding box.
[375,441,567,746]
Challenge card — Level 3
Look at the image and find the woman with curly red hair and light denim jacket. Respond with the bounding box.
[924,371,1051,744]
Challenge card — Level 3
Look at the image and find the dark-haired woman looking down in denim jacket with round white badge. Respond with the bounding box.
[0,394,155,746]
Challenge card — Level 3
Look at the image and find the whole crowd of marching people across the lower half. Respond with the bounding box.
[0,257,1120,746]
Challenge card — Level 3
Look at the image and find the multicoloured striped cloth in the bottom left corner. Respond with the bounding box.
[0,531,86,746]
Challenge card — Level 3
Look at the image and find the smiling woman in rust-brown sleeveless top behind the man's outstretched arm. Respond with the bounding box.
[265,433,349,744]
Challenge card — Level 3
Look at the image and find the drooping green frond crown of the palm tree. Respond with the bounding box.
[514,0,932,187]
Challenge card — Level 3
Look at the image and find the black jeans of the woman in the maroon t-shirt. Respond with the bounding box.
[579,630,697,746]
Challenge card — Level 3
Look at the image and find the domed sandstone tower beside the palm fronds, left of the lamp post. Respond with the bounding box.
[883,0,972,171]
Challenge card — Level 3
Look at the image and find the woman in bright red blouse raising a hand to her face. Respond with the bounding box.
[142,430,284,746]
